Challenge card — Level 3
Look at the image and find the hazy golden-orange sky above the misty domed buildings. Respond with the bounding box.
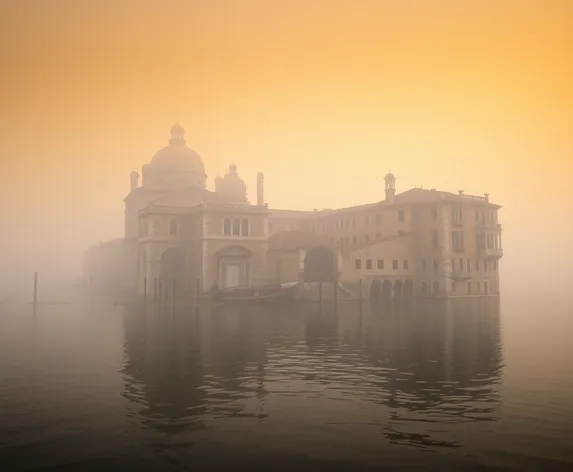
[0,0,573,298]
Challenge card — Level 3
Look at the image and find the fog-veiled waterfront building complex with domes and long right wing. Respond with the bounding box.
[84,123,503,298]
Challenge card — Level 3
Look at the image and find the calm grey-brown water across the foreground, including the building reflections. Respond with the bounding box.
[0,295,573,471]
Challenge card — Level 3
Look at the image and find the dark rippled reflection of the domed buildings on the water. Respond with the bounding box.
[119,299,502,454]
